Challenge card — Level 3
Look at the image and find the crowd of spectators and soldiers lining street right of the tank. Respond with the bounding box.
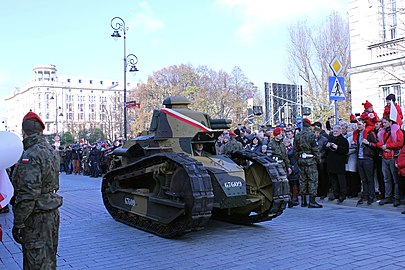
[217,94,405,214]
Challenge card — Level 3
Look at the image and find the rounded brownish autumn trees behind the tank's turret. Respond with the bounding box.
[130,64,257,135]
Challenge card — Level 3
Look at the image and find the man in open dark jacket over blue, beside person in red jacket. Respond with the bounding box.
[353,118,378,205]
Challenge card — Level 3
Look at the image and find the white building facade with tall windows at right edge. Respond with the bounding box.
[349,0,405,116]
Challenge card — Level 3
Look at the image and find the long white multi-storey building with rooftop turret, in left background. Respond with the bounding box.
[5,65,133,139]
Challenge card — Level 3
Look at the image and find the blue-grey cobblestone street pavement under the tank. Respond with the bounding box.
[0,174,405,270]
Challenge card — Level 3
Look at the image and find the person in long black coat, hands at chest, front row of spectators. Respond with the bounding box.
[326,125,349,203]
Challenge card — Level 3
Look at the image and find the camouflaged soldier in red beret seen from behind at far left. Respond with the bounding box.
[12,112,62,269]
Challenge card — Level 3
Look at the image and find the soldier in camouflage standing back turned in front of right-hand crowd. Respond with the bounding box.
[294,118,322,208]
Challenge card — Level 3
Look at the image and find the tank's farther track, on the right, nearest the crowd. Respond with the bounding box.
[213,150,290,225]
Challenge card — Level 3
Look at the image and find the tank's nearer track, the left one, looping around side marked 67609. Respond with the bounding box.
[101,153,214,238]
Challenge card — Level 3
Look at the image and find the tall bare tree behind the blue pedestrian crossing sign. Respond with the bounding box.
[287,12,351,120]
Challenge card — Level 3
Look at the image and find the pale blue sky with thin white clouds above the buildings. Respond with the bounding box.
[0,0,347,101]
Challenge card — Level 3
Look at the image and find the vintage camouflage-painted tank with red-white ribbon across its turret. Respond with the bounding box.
[101,96,289,238]
